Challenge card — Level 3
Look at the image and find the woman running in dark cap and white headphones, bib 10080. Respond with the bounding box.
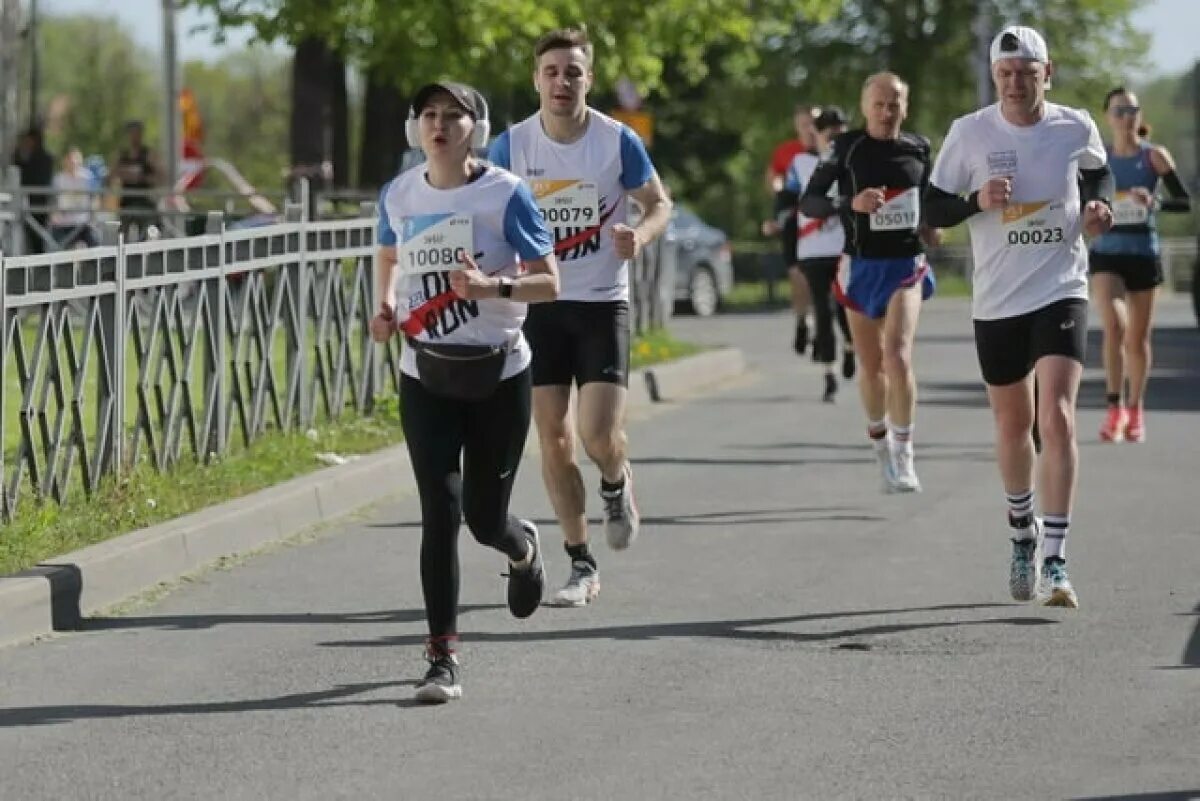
[371,76,558,703]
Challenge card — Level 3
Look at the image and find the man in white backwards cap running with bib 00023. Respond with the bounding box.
[925,26,1114,608]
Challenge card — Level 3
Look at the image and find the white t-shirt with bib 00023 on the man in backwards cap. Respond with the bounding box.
[930,103,1106,320]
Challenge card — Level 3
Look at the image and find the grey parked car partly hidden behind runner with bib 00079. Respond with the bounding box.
[667,205,733,317]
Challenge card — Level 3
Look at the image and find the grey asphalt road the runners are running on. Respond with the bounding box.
[0,300,1200,801]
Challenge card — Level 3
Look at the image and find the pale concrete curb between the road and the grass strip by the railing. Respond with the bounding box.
[0,348,744,645]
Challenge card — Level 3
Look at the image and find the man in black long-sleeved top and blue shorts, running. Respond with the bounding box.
[800,72,936,493]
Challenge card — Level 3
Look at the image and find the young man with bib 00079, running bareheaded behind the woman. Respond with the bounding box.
[488,29,671,607]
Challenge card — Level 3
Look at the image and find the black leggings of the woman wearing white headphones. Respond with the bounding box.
[400,371,530,637]
